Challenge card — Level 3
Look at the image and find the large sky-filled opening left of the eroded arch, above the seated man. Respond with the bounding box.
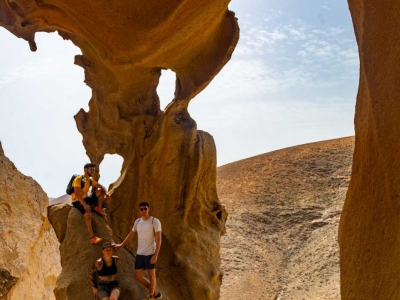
[0,28,91,197]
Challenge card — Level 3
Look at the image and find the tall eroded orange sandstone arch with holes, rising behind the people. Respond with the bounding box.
[0,0,239,299]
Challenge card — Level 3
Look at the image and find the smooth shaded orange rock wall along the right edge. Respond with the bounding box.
[339,0,400,300]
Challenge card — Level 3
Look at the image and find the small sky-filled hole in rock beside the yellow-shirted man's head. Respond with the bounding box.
[99,154,124,189]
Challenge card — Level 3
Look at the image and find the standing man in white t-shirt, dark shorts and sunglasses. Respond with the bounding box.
[114,202,162,300]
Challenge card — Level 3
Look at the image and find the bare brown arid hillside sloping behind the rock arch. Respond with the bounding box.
[217,137,354,300]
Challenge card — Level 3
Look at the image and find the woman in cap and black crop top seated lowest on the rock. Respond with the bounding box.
[89,242,121,300]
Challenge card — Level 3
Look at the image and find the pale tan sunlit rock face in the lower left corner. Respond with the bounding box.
[0,144,61,300]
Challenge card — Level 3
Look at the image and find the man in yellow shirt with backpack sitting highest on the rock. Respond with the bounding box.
[71,163,107,244]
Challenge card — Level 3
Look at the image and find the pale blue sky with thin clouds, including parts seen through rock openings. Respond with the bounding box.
[0,0,359,197]
